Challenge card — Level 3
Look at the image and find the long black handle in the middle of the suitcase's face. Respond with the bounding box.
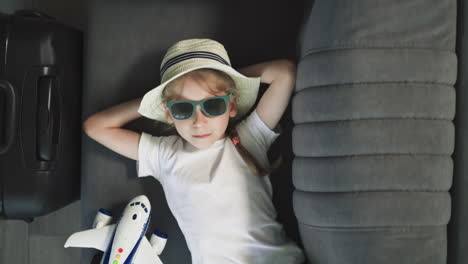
[17,66,61,170]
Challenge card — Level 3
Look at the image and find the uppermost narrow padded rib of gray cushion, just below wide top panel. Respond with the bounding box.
[296,47,457,91]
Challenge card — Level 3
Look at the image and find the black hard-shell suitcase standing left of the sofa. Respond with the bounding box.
[0,11,82,220]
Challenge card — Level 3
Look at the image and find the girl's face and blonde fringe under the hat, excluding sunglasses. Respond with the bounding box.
[166,74,237,149]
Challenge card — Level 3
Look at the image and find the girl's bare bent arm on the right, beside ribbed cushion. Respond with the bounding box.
[238,59,296,129]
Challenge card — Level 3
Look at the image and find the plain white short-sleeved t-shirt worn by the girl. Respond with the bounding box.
[137,111,304,264]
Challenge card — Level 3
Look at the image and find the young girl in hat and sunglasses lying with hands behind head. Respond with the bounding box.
[84,39,304,264]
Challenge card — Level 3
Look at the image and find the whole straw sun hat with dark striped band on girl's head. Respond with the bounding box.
[138,39,260,123]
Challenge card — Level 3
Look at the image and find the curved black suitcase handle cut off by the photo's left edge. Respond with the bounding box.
[0,80,17,155]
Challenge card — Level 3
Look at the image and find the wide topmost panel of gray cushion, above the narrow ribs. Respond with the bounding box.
[300,0,457,54]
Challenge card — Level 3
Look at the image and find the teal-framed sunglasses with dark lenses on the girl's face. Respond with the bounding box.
[166,93,233,120]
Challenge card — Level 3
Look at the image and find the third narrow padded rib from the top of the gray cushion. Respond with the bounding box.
[293,119,454,157]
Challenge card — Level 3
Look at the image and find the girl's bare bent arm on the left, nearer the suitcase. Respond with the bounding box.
[83,98,142,160]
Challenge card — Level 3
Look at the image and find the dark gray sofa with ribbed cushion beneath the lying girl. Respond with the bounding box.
[81,0,468,264]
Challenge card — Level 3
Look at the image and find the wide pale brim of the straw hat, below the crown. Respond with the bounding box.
[138,63,260,123]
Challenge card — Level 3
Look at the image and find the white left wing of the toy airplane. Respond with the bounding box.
[65,225,115,251]
